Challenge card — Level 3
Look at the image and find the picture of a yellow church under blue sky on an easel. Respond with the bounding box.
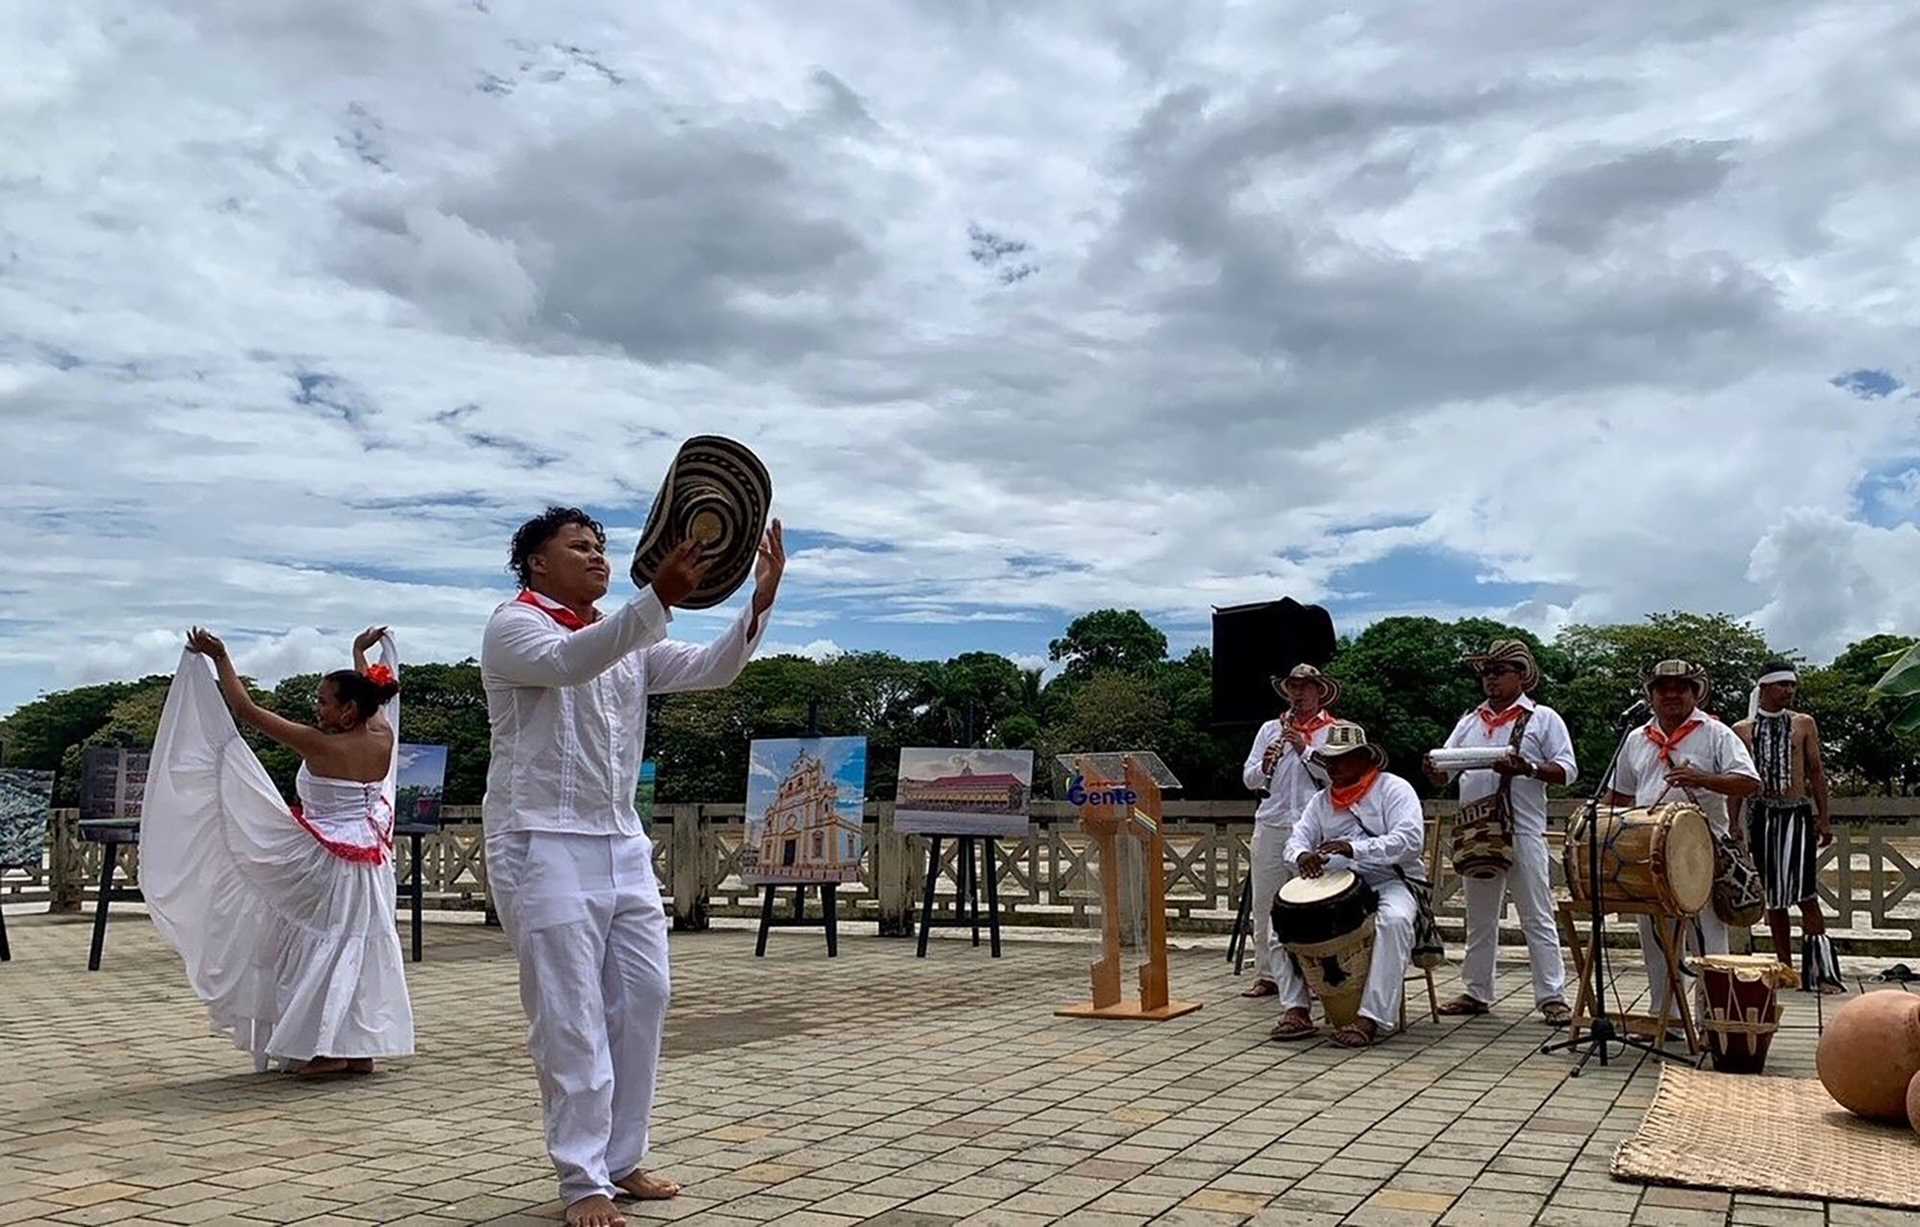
[741,737,866,885]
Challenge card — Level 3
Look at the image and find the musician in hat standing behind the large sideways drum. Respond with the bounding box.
[1613,661,1761,1014]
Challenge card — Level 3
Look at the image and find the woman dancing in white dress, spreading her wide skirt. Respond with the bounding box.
[140,626,413,1077]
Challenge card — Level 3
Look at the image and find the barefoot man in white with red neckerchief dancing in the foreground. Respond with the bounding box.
[480,507,785,1227]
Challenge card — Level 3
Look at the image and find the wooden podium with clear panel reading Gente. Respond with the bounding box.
[1054,753,1200,1022]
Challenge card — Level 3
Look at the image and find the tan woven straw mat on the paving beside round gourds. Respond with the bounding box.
[1613,1066,1920,1208]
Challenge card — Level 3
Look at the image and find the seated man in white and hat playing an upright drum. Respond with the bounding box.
[1286,720,1427,1048]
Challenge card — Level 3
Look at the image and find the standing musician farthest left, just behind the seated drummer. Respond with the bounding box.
[1240,664,1340,1039]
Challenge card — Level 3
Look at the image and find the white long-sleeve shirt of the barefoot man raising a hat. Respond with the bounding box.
[480,588,772,835]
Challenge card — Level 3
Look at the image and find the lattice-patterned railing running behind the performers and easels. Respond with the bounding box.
[0,797,1920,956]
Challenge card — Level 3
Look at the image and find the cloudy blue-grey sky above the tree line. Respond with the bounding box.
[0,0,1920,710]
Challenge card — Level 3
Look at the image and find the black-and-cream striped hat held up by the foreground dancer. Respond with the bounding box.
[632,434,774,609]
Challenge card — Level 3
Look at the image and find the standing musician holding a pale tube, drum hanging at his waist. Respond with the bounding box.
[1425,639,1578,1027]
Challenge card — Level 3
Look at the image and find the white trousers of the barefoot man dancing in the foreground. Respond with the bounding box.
[486,831,670,1204]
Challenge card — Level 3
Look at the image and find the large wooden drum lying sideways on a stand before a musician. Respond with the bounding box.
[1561,803,1715,916]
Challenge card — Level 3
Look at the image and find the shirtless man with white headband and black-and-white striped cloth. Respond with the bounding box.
[1732,661,1847,993]
